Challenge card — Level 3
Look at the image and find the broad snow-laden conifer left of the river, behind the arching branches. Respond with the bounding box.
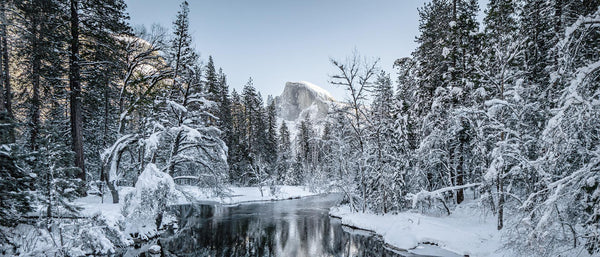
[158,59,227,190]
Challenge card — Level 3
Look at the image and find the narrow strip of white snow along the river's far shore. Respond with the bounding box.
[178,186,317,204]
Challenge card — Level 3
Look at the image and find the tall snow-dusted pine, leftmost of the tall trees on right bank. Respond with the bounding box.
[413,0,478,209]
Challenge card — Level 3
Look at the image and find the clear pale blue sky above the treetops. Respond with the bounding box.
[125,0,485,100]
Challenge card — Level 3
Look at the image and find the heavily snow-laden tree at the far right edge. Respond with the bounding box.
[522,10,600,255]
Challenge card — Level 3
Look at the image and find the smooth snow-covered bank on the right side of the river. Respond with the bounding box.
[330,200,506,256]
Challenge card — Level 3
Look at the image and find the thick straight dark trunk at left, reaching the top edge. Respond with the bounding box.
[69,0,86,195]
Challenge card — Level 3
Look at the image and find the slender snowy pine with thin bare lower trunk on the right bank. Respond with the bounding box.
[482,1,525,230]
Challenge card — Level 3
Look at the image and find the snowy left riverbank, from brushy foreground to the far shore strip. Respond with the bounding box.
[0,186,317,256]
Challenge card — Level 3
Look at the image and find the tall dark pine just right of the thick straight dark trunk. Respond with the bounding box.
[80,0,132,183]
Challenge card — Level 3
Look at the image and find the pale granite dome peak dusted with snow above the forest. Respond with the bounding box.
[275,81,335,121]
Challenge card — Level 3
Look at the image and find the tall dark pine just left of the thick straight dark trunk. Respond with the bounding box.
[5,1,85,217]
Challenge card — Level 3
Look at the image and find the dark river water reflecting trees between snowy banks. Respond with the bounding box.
[130,194,454,257]
